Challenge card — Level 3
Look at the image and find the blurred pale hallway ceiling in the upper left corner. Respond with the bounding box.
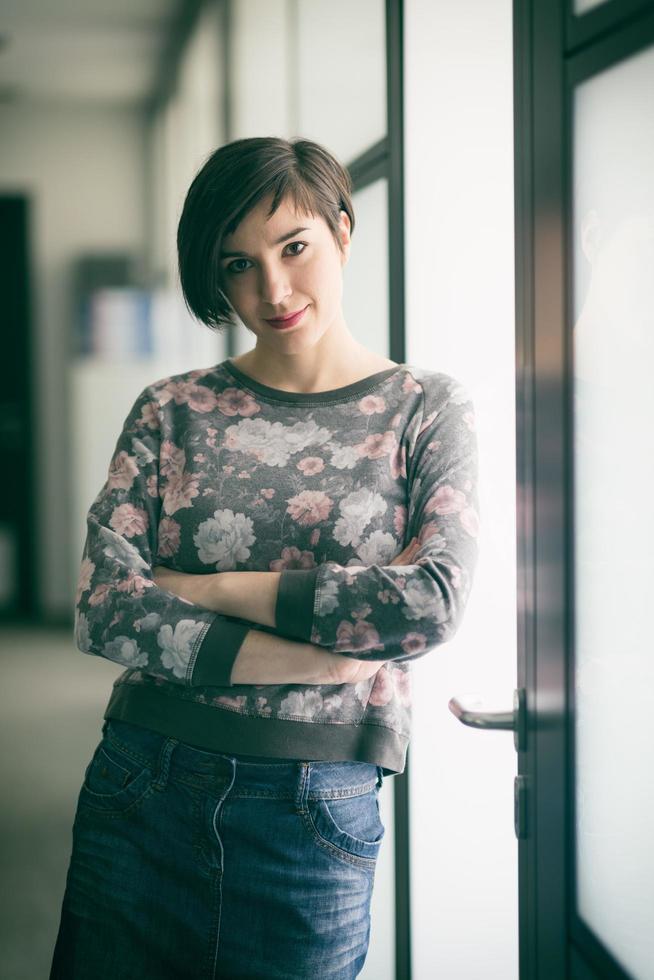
[0,0,180,106]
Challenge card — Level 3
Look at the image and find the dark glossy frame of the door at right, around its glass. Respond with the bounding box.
[513,0,654,980]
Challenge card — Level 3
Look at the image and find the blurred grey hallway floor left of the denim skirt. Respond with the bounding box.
[0,627,123,980]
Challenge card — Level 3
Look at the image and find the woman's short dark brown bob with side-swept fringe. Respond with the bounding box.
[177,136,354,331]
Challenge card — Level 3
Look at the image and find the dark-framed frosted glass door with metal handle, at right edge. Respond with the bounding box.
[514,0,654,980]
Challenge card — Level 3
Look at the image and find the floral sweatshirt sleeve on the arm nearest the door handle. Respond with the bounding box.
[276,374,479,661]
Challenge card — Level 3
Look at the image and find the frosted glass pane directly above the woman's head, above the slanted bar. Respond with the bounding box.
[298,0,387,163]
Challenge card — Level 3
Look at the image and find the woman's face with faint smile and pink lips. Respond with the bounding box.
[220,196,350,354]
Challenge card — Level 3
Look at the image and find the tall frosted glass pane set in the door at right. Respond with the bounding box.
[573,40,654,980]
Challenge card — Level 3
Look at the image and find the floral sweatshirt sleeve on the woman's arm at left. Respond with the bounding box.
[74,388,254,687]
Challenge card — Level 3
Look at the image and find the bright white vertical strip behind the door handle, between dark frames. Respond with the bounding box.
[404,0,518,980]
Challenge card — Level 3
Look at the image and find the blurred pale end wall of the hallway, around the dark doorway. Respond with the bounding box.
[0,105,144,615]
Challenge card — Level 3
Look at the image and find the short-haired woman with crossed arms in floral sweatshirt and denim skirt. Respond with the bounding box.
[51,138,477,980]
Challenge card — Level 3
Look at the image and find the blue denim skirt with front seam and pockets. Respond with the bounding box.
[50,719,384,980]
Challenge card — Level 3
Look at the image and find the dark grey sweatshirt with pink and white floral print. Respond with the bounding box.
[75,358,479,775]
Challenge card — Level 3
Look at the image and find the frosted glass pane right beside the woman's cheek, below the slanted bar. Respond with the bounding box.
[343,179,390,357]
